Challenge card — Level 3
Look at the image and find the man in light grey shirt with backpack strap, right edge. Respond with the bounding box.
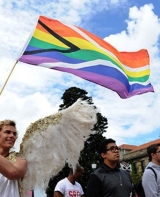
[142,143,160,197]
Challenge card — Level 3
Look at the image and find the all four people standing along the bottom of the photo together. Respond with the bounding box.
[0,120,160,197]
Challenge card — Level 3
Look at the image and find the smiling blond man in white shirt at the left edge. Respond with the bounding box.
[0,120,27,197]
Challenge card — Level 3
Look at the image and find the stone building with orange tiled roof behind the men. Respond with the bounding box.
[119,139,160,174]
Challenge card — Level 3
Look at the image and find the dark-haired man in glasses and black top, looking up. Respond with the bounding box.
[86,138,132,197]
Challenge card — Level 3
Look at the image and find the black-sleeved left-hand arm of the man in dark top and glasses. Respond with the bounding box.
[86,174,102,197]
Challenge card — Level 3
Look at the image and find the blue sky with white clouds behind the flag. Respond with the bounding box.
[0,0,160,197]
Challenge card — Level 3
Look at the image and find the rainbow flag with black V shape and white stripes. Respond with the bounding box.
[19,16,154,98]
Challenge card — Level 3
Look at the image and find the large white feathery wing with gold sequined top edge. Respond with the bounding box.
[20,100,97,196]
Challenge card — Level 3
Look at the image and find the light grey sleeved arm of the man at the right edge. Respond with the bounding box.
[142,169,158,197]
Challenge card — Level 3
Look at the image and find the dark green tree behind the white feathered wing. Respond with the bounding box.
[46,87,108,197]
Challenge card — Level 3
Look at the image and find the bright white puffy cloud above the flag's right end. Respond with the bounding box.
[105,4,160,52]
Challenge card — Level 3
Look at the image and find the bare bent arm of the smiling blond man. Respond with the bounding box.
[0,155,27,180]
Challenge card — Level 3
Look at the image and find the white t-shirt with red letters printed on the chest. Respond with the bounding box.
[54,178,84,197]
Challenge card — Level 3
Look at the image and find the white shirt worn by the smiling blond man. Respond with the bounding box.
[0,174,19,197]
